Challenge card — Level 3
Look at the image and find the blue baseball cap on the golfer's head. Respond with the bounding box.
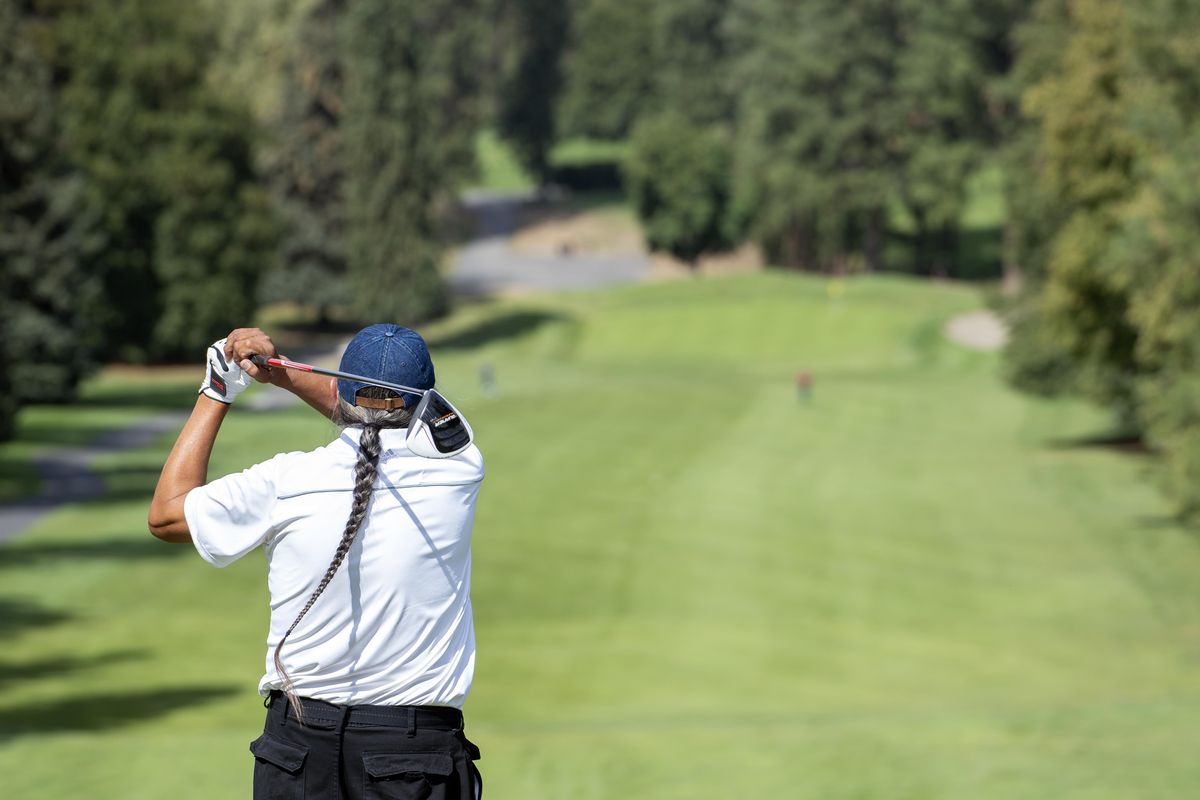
[337,323,433,409]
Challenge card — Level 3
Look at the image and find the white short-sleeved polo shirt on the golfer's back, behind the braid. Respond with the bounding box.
[184,428,484,708]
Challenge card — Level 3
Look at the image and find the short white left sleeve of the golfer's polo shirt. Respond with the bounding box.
[184,458,278,567]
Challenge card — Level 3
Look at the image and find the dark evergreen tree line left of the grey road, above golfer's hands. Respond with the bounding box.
[0,0,486,438]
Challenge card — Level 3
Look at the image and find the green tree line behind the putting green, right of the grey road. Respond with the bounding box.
[498,0,1030,275]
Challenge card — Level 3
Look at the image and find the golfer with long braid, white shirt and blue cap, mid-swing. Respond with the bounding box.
[149,325,484,800]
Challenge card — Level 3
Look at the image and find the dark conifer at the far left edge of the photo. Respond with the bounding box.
[0,0,100,422]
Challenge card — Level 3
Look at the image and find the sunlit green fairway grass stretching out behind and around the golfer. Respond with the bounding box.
[0,273,1200,800]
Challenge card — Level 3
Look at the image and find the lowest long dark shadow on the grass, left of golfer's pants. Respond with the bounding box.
[0,686,239,741]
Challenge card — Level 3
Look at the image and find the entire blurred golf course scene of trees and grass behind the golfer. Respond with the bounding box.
[0,0,1200,800]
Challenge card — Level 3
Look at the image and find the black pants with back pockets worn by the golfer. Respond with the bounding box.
[250,692,484,800]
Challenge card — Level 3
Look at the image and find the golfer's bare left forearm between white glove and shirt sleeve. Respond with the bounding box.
[146,395,229,545]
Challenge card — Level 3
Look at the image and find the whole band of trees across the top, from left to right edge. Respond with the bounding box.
[7,0,1200,516]
